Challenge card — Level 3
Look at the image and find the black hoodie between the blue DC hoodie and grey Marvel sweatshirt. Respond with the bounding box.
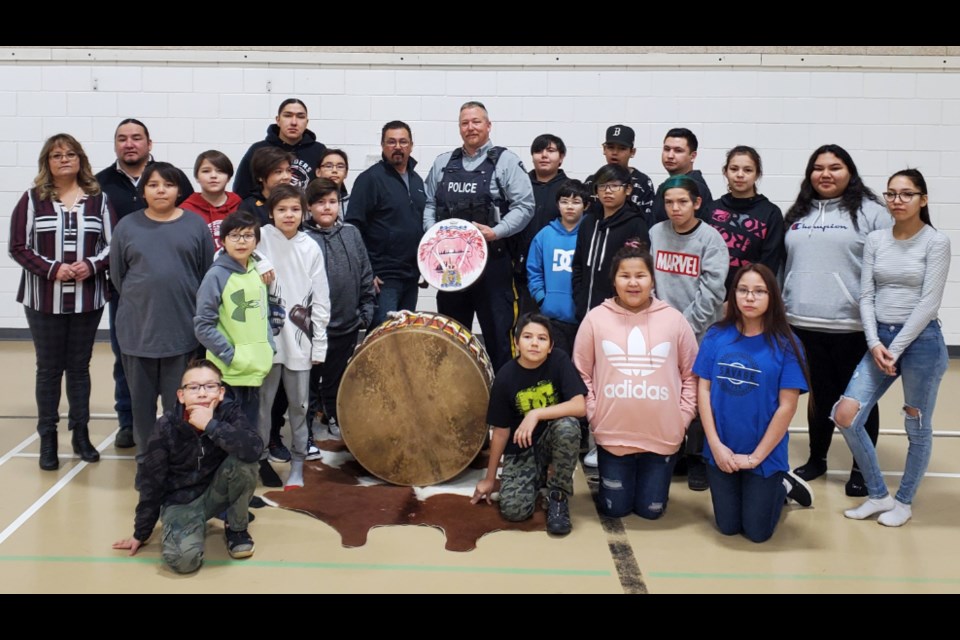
[573,205,650,320]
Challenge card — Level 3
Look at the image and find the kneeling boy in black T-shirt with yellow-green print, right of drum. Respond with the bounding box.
[470,313,587,536]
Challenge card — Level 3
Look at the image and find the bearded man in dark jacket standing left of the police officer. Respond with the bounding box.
[345,120,427,327]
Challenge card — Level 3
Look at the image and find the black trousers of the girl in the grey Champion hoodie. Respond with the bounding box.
[793,327,880,460]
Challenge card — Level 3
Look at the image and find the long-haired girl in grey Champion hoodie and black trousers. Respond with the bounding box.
[783,144,890,496]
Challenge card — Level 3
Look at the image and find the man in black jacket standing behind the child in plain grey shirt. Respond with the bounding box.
[97,118,193,449]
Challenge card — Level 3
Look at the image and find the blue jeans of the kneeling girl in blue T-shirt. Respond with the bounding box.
[707,464,787,542]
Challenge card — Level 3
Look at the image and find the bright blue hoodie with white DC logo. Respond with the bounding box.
[527,218,583,324]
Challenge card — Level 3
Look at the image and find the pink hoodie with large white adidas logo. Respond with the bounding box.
[573,298,697,455]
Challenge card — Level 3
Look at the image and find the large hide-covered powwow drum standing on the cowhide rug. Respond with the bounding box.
[337,311,493,486]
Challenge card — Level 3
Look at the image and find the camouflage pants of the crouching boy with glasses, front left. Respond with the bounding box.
[160,456,259,573]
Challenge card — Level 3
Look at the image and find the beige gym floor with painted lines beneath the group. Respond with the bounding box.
[0,342,960,593]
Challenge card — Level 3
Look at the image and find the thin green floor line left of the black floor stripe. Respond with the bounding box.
[0,556,613,577]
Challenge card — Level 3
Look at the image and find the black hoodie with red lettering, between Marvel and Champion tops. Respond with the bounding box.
[705,193,786,291]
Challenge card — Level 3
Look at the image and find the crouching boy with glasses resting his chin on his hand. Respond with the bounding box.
[113,360,263,573]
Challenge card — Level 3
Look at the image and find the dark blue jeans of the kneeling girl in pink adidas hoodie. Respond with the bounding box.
[597,446,678,520]
